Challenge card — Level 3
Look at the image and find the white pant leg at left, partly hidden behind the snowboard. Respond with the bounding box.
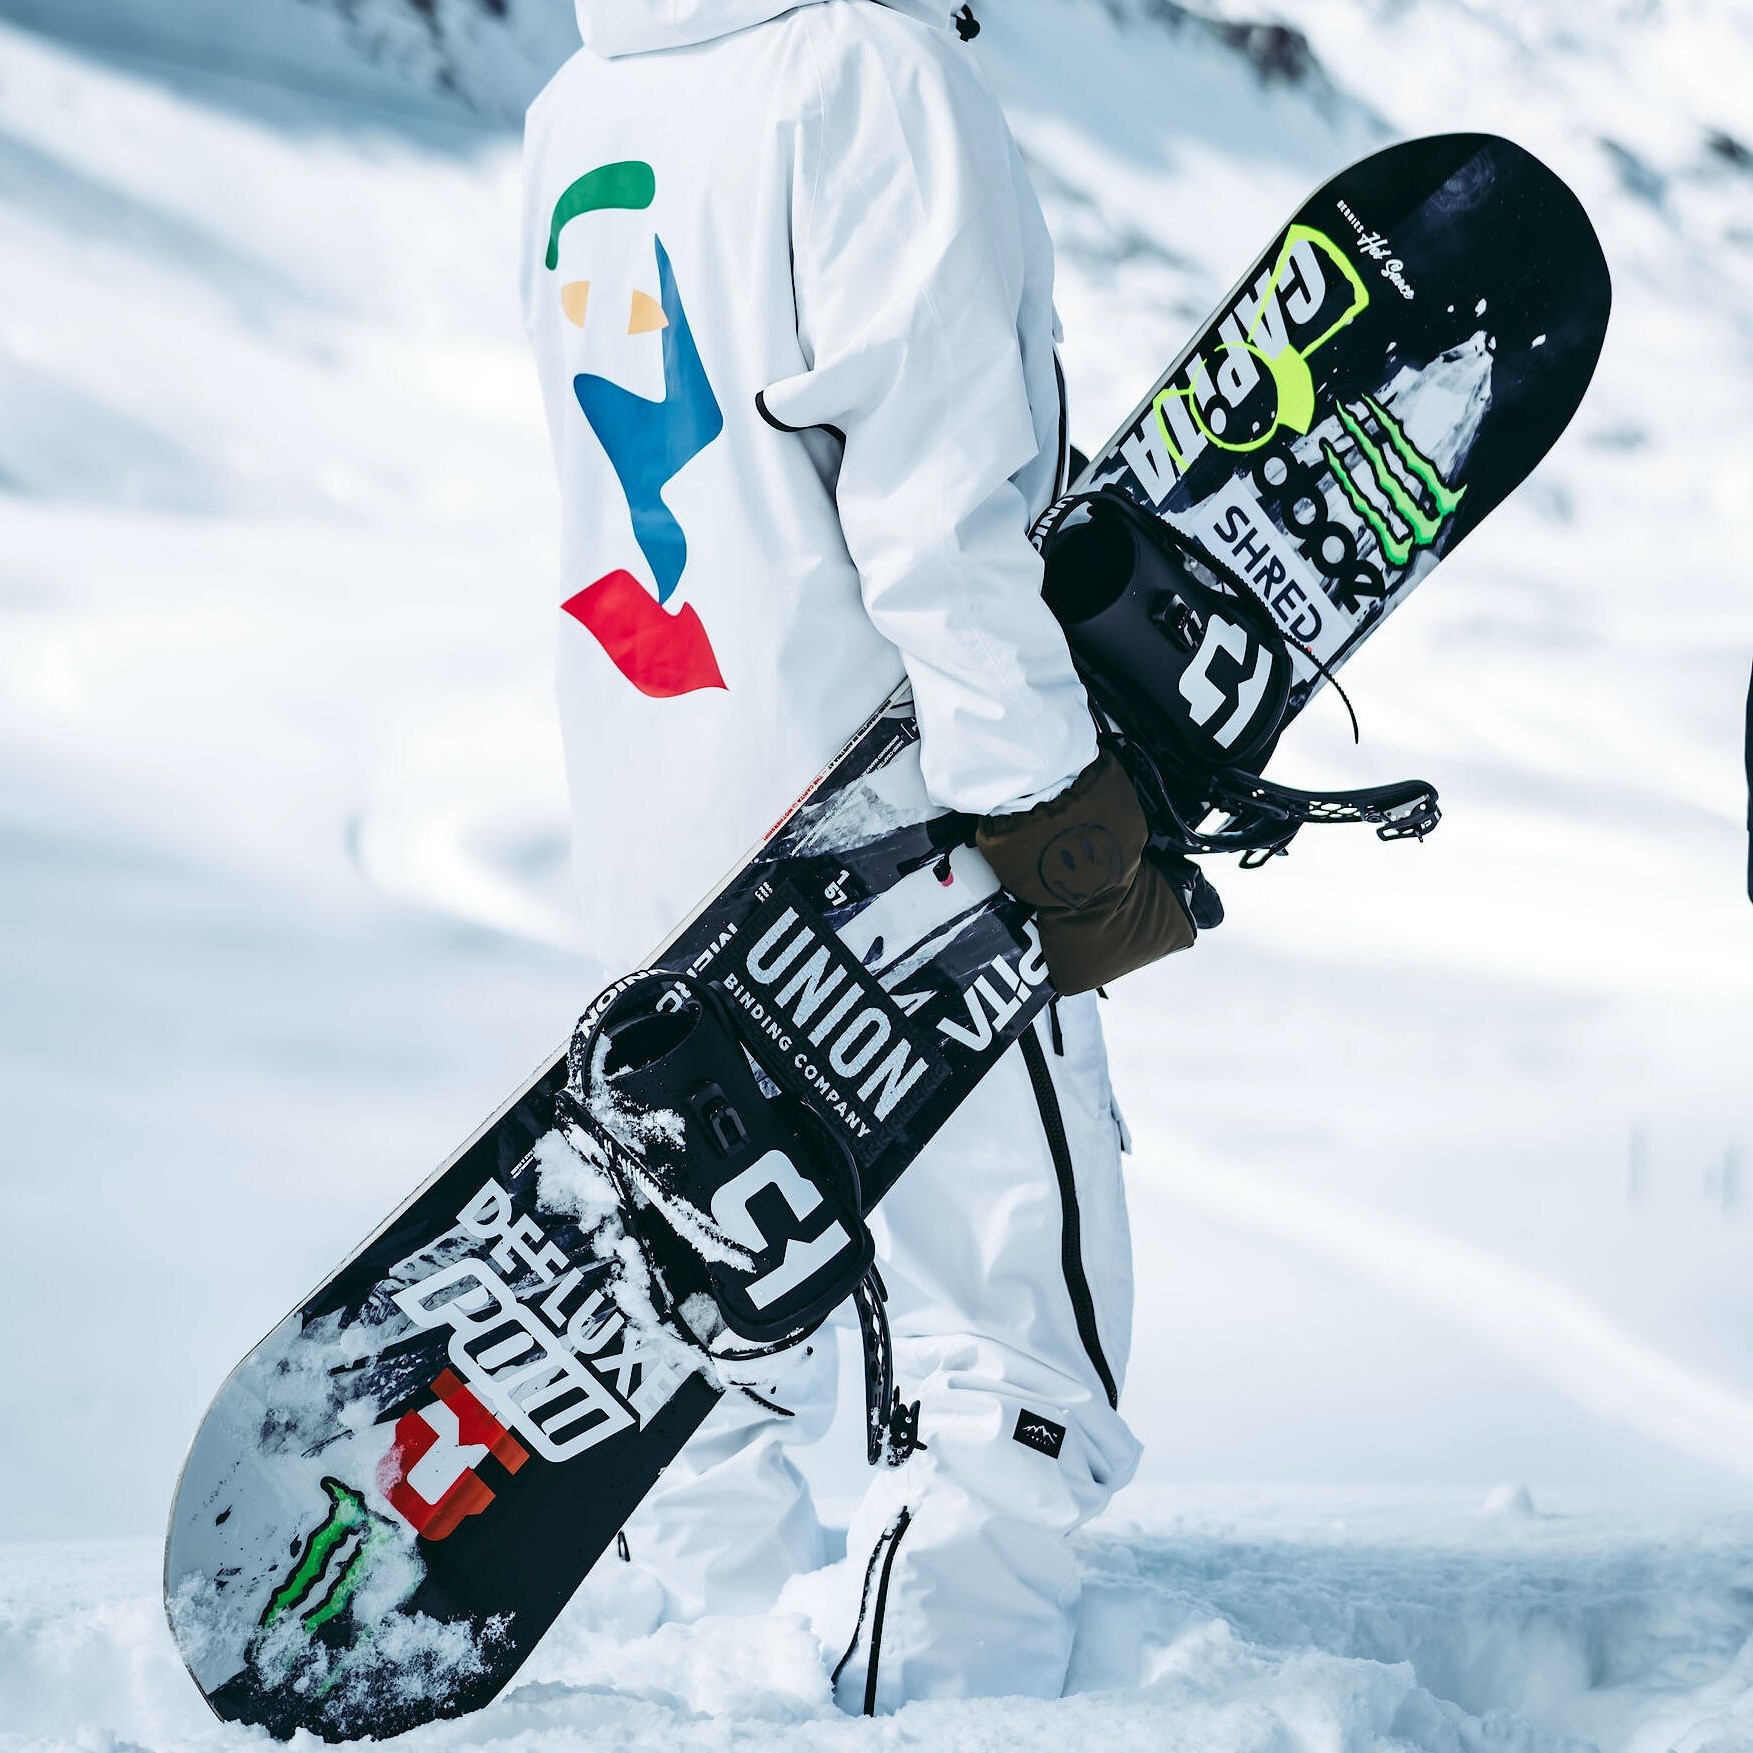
[626,1329,836,1620]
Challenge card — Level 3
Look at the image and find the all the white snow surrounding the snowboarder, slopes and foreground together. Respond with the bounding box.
[0,0,1753,1753]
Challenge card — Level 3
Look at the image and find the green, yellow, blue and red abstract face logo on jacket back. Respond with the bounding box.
[547,160,724,699]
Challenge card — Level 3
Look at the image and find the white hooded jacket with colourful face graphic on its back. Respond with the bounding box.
[522,0,1096,968]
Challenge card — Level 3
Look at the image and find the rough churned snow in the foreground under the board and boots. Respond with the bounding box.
[0,1487,1753,1753]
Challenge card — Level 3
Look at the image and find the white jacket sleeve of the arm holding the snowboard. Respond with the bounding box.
[761,17,1096,815]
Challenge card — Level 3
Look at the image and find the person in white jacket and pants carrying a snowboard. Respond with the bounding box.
[522,0,1194,1711]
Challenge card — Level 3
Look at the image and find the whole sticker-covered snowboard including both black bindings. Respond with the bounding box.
[165,135,1609,1739]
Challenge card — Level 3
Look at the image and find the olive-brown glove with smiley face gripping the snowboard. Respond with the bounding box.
[975,750,1194,996]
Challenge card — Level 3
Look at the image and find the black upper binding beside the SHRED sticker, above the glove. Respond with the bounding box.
[1036,489,1441,868]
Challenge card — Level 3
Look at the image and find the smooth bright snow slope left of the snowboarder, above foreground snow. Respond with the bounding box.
[0,13,593,1556]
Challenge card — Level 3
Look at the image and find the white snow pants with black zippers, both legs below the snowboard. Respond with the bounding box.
[629,997,1139,1713]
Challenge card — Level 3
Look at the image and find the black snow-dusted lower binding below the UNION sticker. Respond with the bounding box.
[566,971,919,1464]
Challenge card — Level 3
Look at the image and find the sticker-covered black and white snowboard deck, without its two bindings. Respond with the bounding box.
[165,135,1609,1739]
